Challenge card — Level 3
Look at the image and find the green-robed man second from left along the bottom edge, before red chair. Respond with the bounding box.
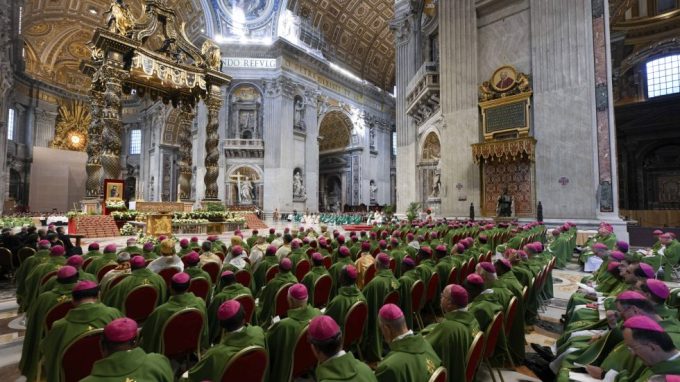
[188,300,267,382]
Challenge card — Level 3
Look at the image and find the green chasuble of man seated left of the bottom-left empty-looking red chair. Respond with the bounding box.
[19,284,74,381]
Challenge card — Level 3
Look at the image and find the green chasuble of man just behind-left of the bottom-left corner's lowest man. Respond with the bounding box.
[40,302,123,382]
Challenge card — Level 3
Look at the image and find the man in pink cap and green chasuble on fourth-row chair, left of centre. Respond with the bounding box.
[135,272,208,353]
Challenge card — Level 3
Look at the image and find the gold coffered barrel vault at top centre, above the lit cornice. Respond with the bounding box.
[288,0,395,91]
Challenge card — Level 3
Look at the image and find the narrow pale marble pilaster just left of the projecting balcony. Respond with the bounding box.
[391,0,420,213]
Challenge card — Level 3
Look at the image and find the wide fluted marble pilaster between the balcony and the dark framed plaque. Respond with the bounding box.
[439,0,480,216]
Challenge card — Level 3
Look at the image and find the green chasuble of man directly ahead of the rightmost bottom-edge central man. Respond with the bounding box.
[360,269,399,362]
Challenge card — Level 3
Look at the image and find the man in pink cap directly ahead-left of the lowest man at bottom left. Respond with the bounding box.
[41,281,123,382]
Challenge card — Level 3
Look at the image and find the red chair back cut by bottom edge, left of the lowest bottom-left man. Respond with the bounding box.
[61,329,104,382]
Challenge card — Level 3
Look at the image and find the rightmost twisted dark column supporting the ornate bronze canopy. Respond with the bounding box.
[203,85,222,201]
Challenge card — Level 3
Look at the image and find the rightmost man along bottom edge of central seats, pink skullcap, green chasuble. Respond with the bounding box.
[375,304,442,382]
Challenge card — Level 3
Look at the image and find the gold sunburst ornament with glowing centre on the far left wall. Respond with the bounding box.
[50,101,92,151]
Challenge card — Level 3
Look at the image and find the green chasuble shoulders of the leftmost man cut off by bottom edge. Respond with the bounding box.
[80,348,174,382]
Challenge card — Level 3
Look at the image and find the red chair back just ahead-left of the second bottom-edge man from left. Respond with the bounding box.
[161,308,203,360]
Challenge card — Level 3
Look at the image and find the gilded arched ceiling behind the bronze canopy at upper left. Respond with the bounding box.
[22,0,205,93]
